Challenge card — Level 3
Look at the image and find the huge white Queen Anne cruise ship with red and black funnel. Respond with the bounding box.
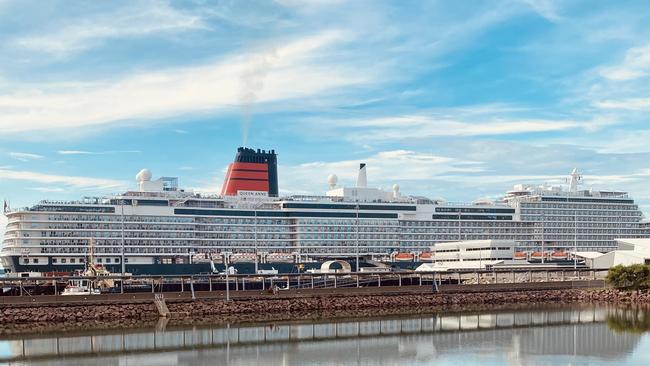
[0,147,648,274]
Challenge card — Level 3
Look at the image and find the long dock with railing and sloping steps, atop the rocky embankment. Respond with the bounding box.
[0,269,607,306]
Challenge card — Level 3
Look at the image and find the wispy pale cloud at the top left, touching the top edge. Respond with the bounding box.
[15,0,207,55]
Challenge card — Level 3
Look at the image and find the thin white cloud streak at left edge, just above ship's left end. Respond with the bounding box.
[0,169,127,189]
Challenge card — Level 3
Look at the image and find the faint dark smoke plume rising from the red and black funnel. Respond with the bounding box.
[239,50,276,146]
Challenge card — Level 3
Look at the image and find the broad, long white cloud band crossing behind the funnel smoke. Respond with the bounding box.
[0,30,364,134]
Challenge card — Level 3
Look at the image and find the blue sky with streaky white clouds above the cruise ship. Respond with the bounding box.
[0,0,650,226]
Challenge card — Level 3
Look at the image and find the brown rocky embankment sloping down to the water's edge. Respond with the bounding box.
[0,289,650,333]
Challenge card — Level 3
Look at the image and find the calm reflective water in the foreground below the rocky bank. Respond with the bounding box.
[0,307,650,366]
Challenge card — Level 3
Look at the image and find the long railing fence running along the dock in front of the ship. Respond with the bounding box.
[0,268,607,298]
